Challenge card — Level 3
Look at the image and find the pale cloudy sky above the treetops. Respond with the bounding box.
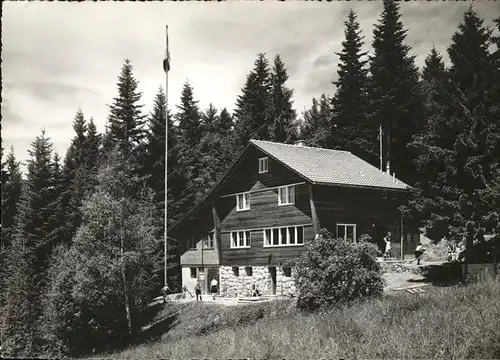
[2,0,500,174]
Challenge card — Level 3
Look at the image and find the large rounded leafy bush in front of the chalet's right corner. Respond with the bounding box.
[294,230,384,310]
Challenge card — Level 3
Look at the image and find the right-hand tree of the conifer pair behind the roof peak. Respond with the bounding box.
[268,55,297,143]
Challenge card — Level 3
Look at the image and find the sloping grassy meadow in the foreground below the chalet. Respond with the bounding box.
[94,277,500,359]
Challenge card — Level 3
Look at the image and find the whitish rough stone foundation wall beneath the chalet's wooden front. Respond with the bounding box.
[220,266,296,297]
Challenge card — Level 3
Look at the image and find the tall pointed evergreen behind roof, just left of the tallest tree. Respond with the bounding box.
[328,10,377,163]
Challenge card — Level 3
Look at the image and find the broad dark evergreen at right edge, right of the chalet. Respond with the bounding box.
[410,8,500,246]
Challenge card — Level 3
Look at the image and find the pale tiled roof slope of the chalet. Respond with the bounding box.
[250,140,411,190]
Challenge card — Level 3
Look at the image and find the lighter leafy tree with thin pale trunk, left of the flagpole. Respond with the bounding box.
[42,152,161,355]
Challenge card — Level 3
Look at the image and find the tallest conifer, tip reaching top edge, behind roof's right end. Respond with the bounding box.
[369,0,423,184]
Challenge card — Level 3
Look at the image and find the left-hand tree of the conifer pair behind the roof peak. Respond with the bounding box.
[234,53,271,147]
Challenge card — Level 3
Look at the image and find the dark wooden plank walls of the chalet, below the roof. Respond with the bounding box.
[169,140,416,292]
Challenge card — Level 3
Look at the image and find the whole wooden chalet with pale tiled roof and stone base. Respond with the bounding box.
[169,140,418,296]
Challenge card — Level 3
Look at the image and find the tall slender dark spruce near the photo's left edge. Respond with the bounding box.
[2,131,61,357]
